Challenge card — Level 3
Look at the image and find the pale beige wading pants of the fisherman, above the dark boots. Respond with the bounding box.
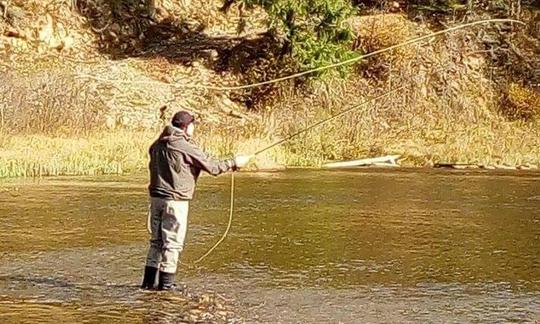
[146,197,189,273]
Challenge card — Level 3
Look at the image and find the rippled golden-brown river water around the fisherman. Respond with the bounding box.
[0,169,540,323]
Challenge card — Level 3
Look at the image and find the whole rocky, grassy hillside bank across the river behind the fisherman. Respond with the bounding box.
[0,0,540,177]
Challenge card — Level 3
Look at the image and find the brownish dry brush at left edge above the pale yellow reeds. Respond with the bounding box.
[0,65,105,134]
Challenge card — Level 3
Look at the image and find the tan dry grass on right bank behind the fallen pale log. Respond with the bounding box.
[258,80,540,166]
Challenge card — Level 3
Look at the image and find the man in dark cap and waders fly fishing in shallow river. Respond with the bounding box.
[141,111,250,290]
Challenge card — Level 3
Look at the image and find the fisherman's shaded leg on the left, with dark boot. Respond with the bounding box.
[141,198,165,289]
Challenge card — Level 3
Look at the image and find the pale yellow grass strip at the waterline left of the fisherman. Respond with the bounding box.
[0,132,153,177]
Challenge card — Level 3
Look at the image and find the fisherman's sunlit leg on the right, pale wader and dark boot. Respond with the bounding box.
[158,200,189,290]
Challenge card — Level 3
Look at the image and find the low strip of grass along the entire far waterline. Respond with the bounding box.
[0,116,540,177]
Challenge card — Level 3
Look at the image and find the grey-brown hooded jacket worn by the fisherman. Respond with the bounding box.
[148,126,236,200]
